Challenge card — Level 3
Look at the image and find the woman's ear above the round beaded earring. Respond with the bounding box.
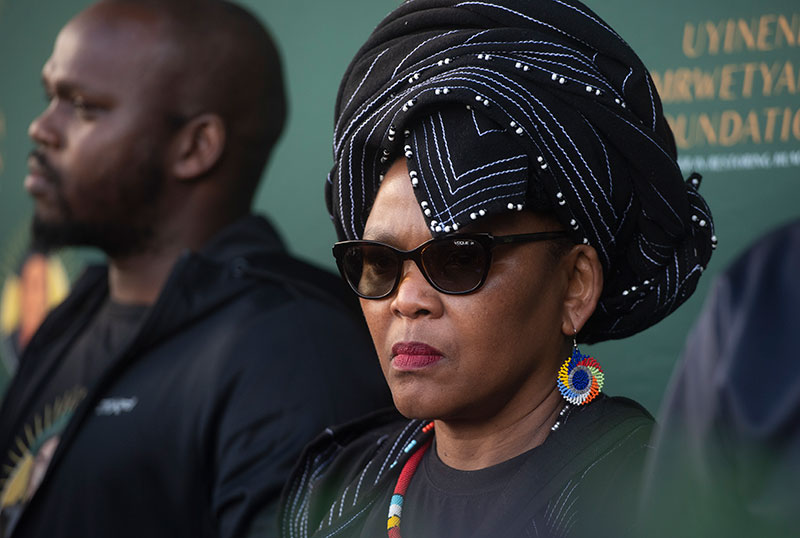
[561,245,603,336]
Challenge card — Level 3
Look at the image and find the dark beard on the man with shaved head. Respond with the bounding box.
[31,150,163,258]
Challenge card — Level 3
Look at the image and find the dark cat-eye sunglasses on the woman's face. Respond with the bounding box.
[333,231,567,299]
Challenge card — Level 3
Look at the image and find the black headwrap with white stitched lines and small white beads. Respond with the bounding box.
[326,0,716,342]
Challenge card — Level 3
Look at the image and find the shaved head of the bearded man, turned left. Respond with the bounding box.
[26,0,286,257]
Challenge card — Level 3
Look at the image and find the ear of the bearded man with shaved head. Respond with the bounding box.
[169,114,225,181]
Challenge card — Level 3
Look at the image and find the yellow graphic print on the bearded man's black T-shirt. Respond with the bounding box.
[0,387,86,510]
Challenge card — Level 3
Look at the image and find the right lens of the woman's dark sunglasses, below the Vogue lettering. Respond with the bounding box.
[422,237,488,293]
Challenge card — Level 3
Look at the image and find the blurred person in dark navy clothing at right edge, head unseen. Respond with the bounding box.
[641,219,800,538]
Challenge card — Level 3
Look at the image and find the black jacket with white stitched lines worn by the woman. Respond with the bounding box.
[279,394,653,538]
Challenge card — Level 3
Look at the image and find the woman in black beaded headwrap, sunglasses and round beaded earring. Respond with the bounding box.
[281,0,716,537]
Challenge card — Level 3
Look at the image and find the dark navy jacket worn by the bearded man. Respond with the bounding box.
[0,217,390,538]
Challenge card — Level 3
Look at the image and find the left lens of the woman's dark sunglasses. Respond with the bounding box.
[341,245,399,297]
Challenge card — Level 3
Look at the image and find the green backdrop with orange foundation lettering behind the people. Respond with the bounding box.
[0,0,800,412]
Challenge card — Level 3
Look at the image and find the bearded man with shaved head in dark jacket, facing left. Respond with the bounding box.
[0,0,388,537]
